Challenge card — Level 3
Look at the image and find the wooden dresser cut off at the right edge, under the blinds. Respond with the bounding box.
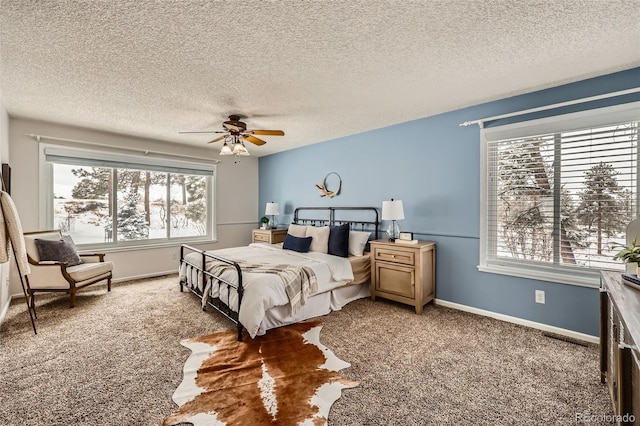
[600,271,640,425]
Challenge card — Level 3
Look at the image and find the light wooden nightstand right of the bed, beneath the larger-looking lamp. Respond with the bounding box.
[370,240,436,314]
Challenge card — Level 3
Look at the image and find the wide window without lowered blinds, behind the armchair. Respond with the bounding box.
[41,146,215,247]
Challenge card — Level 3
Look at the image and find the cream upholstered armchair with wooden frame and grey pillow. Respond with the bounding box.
[24,230,113,312]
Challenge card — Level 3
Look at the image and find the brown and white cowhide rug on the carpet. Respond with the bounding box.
[163,321,358,426]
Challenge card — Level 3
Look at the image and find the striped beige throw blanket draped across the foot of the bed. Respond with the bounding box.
[202,262,318,315]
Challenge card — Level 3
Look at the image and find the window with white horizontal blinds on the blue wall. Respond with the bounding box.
[480,104,640,285]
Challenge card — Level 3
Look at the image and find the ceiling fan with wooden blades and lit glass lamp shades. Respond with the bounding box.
[179,115,284,155]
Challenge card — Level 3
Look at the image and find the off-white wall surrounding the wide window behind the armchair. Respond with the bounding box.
[9,118,259,295]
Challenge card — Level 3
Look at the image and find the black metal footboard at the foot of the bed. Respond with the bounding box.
[180,244,244,342]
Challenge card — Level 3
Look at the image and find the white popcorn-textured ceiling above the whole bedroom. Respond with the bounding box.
[0,0,640,155]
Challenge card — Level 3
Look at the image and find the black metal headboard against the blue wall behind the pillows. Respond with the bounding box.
[292,207,380,239]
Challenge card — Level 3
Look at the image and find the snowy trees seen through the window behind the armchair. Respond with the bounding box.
[53,163,209,244]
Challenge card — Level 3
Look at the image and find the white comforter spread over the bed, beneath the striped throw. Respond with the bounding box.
[180,243,353,337]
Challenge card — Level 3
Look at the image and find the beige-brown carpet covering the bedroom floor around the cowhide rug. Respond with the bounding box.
[0,276,612,426]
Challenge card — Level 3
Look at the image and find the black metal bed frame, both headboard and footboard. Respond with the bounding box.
[180,207,380,342]
